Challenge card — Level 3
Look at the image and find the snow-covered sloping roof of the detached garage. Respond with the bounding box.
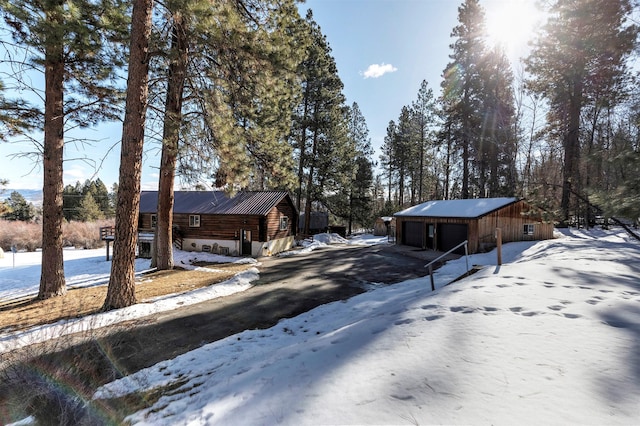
[394,197,518,219]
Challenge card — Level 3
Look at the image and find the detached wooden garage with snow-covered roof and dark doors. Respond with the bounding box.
[394,198,553,254]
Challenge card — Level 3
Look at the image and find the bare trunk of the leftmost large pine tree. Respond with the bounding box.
[38,12,67,299]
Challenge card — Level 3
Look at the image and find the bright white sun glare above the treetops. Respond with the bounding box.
[485,0,543,52]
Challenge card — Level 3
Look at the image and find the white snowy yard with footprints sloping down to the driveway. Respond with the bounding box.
[0,230,640,425]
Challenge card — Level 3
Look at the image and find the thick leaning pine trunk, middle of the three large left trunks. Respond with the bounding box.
[103,0,153,310]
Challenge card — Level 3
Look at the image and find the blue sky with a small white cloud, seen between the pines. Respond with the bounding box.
[0,0,536,189]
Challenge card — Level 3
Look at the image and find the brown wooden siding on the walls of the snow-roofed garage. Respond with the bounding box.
[396,200,553,253]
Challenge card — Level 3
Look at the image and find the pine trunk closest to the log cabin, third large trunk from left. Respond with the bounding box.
[155,14,188,270]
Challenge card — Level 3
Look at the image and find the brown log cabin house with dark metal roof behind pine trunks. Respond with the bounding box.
[138,191,298,257]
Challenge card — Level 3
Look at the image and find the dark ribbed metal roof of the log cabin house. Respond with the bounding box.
[140,191,295,216]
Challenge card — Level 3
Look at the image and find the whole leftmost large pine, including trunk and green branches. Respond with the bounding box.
[0,0,126,299]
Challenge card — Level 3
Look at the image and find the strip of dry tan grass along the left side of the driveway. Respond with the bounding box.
[0,263,253,332]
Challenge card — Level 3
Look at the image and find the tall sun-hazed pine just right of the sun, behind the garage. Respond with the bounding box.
[526,0,637,224]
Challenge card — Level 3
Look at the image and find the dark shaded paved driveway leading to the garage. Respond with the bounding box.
[105,245,436,372]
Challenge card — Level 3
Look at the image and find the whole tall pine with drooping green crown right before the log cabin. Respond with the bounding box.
[155,0,298,269]
